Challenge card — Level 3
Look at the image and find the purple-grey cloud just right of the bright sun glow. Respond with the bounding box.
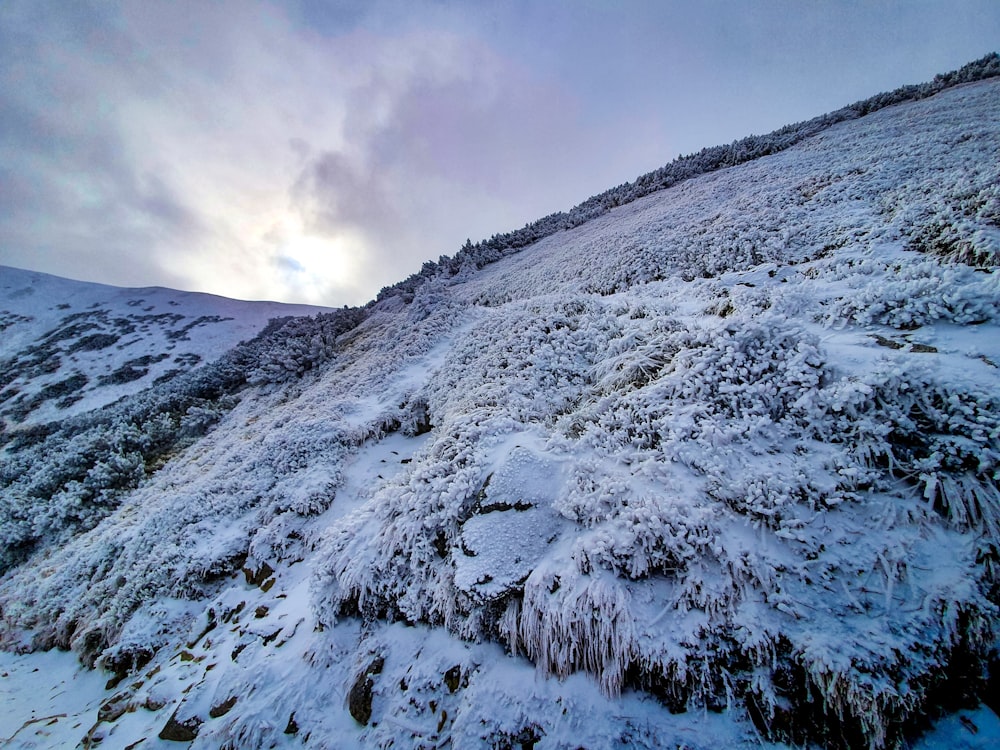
[282,29,648,296]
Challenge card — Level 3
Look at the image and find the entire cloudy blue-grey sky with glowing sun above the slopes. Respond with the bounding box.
[0,0,1000,307]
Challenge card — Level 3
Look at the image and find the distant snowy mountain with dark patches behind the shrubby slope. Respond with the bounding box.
[0,266,327,426]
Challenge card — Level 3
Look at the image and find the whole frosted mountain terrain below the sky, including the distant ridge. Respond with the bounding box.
[0,56,1000,750]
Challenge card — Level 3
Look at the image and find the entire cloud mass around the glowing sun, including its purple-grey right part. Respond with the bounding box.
[0,0,620,304]
